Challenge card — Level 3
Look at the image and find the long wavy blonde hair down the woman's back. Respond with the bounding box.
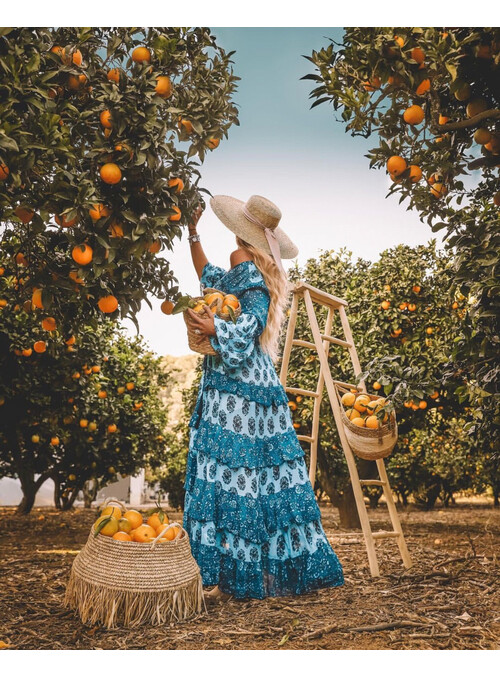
[236,236,289,362]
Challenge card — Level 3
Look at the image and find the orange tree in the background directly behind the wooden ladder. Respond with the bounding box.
[282,242,472,527]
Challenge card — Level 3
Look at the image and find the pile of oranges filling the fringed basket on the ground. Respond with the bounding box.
[93,506,182,544]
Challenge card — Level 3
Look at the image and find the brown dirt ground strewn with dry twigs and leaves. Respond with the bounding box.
[0,502,500,650]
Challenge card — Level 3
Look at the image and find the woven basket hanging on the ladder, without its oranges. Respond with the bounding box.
[336,386,398,461]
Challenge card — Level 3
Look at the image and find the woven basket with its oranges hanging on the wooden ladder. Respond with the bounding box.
[336,385,398,461]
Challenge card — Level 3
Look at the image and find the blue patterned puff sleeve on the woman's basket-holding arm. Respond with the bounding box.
[210,288,270,371]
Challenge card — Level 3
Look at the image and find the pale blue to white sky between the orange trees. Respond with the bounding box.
[124,27,442,355]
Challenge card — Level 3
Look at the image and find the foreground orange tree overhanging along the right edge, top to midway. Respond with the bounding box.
[305,27,500,460]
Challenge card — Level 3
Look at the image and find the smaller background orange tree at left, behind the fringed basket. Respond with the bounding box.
[0,260,167,512]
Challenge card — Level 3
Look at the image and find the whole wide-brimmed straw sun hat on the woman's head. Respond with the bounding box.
[210,195,299,259]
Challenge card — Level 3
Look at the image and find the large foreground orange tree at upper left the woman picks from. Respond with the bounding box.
[0,27,238,330]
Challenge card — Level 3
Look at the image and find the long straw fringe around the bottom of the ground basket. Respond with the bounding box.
[64,572,205,629]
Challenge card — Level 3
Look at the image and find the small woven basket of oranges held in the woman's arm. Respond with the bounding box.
[172,287,241,355]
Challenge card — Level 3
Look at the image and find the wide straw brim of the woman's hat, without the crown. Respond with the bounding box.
[210,195,299,259]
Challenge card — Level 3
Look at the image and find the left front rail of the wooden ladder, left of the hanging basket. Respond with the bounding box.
[304,290,380,577]
